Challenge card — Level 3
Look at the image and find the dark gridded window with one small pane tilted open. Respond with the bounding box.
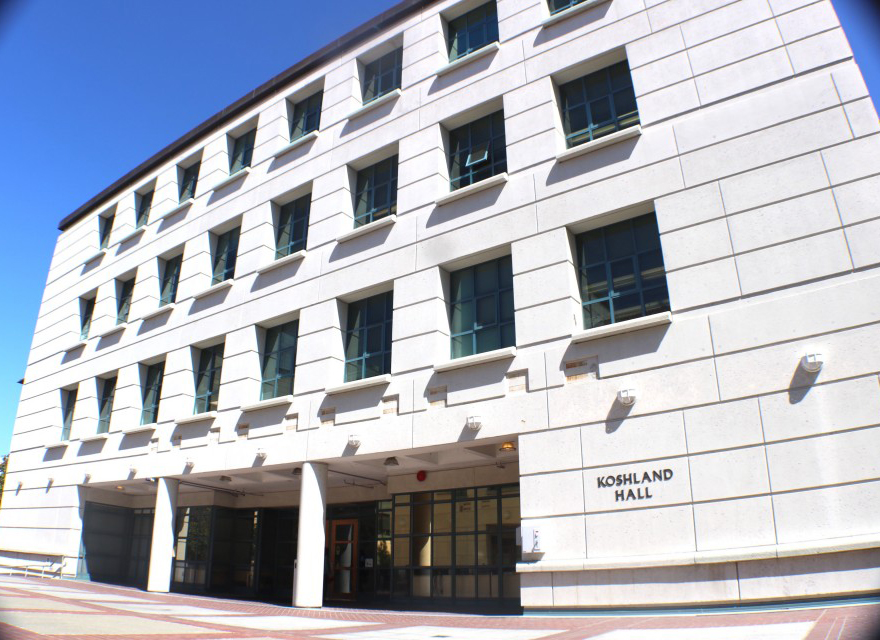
[449,111,507,191]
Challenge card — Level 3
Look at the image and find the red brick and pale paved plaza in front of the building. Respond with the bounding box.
[0,576,880,640]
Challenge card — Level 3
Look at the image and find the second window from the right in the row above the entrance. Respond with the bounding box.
[450,256,516,358]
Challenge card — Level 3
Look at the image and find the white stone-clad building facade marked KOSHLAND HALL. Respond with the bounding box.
[0,0,880,610]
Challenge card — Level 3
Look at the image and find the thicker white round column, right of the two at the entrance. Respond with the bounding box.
[294,462,327,607]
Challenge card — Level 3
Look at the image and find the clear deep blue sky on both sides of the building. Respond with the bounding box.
[0,0,880,454]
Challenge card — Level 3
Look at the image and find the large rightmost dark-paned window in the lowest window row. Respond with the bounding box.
[577,213,669,329]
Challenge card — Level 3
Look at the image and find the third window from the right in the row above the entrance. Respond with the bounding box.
[345,291,392,382]
